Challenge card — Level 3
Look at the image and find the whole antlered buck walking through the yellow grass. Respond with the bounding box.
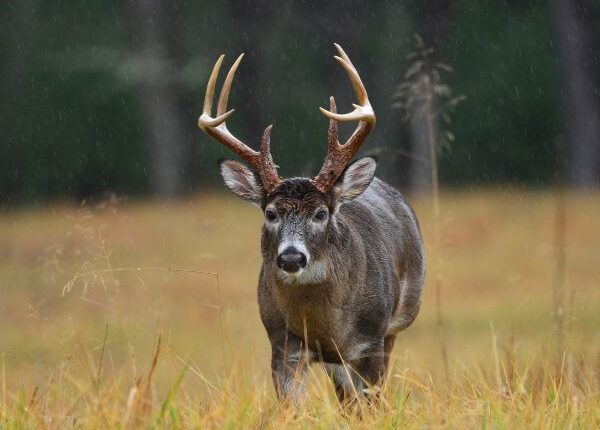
[198,44,424,399]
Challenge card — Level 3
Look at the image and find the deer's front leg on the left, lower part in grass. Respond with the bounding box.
[271,332,308,402]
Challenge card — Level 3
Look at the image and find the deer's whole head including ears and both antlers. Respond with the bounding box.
[198,44,376,283]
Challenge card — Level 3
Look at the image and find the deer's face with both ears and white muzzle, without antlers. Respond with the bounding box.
[221,157,376,284]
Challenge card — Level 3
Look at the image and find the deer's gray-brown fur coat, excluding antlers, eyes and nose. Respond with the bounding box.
[221,159,425,398]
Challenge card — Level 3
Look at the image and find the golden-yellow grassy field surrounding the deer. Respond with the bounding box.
[0,190,600,429]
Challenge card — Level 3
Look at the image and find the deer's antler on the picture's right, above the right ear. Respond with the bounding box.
[312,43,375,193]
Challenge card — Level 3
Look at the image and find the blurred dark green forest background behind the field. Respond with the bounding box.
[0,0,600,208]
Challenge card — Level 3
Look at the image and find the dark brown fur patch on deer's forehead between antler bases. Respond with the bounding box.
[266,178,332,214]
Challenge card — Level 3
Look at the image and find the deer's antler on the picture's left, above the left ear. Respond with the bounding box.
[198,54,281,193]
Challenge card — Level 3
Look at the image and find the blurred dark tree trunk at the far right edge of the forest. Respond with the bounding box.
[554,0,600,188]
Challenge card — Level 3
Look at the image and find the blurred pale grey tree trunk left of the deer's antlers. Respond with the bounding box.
[131,0,189,198]
